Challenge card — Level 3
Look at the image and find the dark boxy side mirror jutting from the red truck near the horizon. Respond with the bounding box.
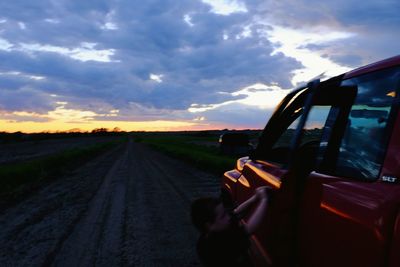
[219,132,252,156]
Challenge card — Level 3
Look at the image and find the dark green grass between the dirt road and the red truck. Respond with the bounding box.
[134,131,260,175]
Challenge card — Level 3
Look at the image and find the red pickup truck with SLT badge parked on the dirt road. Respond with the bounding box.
[221,56,400,267]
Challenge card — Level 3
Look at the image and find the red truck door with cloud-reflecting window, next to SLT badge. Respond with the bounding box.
[294,67,400,267]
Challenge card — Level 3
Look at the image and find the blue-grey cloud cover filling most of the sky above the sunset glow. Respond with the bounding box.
[0,0,400,127]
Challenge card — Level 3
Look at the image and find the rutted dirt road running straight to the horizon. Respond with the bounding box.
[0,141,218,266]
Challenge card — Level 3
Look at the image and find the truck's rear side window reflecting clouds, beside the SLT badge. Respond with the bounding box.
[331,67,400,180]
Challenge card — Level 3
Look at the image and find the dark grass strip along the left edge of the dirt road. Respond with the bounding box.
[0,138,126,206]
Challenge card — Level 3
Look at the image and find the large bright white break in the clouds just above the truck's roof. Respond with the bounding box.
[268,26,353,85]
